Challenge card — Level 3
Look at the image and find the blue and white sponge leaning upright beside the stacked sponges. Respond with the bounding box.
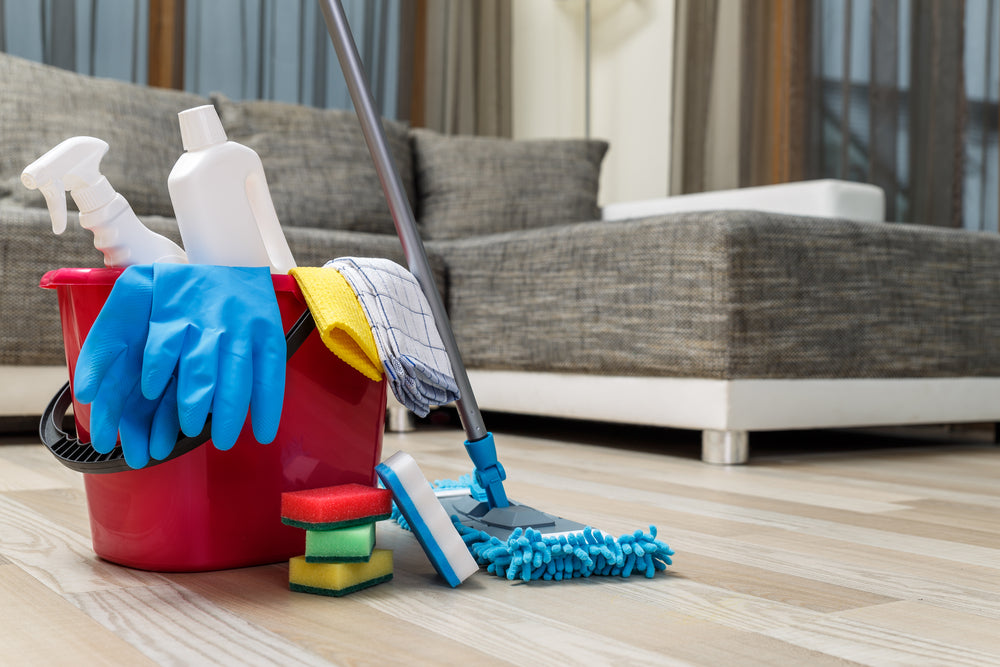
[375,452,479,587]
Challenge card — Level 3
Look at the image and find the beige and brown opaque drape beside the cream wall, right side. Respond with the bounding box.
[670,0,811,194]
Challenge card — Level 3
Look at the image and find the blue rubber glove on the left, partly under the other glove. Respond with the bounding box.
[73,265,180,468]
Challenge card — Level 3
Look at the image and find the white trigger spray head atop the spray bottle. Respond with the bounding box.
[21,137,115,234]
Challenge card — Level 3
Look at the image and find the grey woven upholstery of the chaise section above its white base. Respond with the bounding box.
[439,211,1000,379]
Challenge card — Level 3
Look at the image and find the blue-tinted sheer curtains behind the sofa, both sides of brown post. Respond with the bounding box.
[0,0,413,120]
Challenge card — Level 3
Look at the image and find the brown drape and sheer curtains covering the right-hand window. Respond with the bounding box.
[670,0,1000,230]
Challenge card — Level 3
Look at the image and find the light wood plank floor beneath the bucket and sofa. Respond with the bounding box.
[0,421,1000,666]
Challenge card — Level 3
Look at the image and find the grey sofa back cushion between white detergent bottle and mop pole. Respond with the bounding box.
[213,95,414,234]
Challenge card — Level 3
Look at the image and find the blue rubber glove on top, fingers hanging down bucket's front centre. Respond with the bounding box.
[142,264,286,450]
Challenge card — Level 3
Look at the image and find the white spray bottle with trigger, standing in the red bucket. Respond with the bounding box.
[21,137,187,267]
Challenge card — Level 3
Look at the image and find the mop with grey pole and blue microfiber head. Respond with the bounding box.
[320,0,673,586]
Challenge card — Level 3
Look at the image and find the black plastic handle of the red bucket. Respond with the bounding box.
[38,309,316,474]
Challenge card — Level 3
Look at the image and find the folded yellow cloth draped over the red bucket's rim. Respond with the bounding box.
[289,266,382,382]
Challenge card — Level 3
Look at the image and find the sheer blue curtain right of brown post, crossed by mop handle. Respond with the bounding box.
[184,0,413,119]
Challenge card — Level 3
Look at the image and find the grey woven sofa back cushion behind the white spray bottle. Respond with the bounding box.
[0,53,208,216]
